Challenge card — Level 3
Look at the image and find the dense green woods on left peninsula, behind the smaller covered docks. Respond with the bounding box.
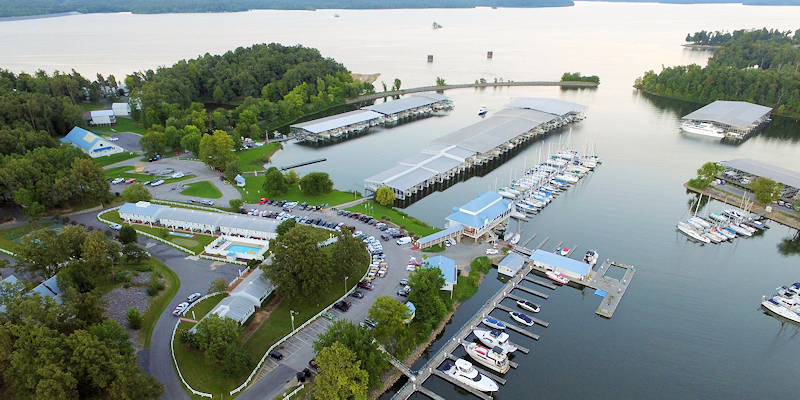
[125,43,374,170]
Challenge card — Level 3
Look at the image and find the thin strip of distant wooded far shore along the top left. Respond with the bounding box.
[0,0,574,17]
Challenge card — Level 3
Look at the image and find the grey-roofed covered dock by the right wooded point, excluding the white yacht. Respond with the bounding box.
[682,100,772,139]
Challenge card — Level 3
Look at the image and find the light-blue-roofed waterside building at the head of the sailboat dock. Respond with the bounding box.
[445,192,514,241]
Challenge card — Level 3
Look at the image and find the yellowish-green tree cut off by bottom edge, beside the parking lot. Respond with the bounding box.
[314,342,369,400]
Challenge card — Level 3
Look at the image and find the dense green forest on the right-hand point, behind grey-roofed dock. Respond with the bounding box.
[634,29,800,115]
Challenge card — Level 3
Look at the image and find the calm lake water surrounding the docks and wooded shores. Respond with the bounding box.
[0,3,800,399]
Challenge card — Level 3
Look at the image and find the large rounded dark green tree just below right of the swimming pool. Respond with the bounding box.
[262,228,333,302]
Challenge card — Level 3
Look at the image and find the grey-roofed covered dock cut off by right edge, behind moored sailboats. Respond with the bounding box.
[720,158,800,202]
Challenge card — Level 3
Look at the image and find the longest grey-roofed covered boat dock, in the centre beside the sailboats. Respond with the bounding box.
[364,98,586,203]
